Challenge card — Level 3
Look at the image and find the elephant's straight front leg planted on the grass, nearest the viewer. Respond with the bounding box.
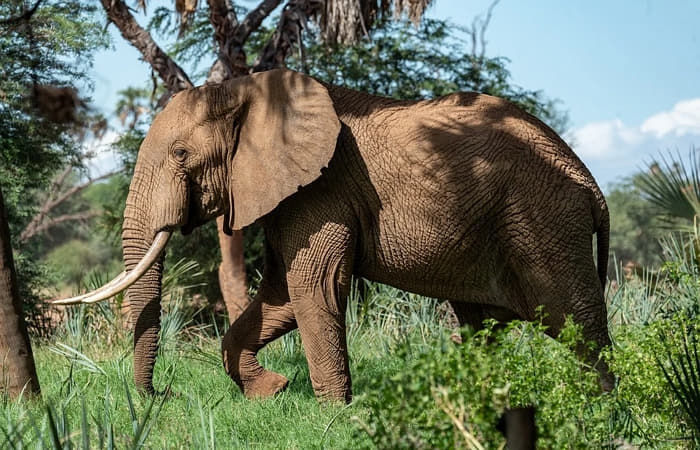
[287,226,352,402]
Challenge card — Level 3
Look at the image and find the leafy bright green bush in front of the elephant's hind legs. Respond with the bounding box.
[358,319,689,448]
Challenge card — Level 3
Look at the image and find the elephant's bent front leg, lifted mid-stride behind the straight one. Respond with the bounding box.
[221,285,297,398]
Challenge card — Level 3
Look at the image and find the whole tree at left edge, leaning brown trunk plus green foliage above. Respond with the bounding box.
[0,0,104,390]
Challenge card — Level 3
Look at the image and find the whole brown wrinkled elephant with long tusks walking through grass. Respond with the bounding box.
[54,69,614,401]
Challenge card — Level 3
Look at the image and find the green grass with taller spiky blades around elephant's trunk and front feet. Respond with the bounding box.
[0,287,448,449]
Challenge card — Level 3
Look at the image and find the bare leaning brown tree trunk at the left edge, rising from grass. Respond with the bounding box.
[0,186,39,397]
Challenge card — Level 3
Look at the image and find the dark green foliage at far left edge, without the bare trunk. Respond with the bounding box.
[0,0,107,328]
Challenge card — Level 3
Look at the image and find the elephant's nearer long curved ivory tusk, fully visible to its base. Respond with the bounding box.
[51,231,171,305]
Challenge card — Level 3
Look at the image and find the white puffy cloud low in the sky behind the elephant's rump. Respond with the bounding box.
[571,98,700,185]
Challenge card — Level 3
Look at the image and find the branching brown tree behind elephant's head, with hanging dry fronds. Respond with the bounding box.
[101,0,432,321]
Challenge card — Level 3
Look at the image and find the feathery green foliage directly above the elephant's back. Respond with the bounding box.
[288,18,568,133]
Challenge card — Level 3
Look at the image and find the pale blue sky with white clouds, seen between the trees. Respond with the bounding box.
[93,0,700,186]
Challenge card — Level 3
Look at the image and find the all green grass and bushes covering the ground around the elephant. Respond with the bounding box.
[0,266,700,448]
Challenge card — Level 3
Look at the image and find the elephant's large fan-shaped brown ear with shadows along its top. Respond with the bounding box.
[229,70,340,230]
